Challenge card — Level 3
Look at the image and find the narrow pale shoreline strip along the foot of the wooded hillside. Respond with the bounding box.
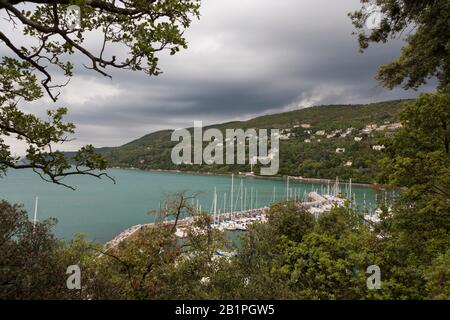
[108,166,377,189]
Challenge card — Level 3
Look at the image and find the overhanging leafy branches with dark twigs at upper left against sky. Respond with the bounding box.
[0,0,199,186]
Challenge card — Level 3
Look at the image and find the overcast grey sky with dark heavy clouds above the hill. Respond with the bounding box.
[0,0,431,154]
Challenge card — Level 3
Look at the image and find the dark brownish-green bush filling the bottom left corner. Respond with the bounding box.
[0,201,84,299]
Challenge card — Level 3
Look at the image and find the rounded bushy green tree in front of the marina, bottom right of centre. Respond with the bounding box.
[232,203,386,299]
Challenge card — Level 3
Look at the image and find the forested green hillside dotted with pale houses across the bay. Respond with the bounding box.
[98,101,405,182]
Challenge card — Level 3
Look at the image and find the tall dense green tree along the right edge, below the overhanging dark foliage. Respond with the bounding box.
[372,86,450,299]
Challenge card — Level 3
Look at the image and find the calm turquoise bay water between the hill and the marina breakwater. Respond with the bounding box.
[0,169,375,242]
